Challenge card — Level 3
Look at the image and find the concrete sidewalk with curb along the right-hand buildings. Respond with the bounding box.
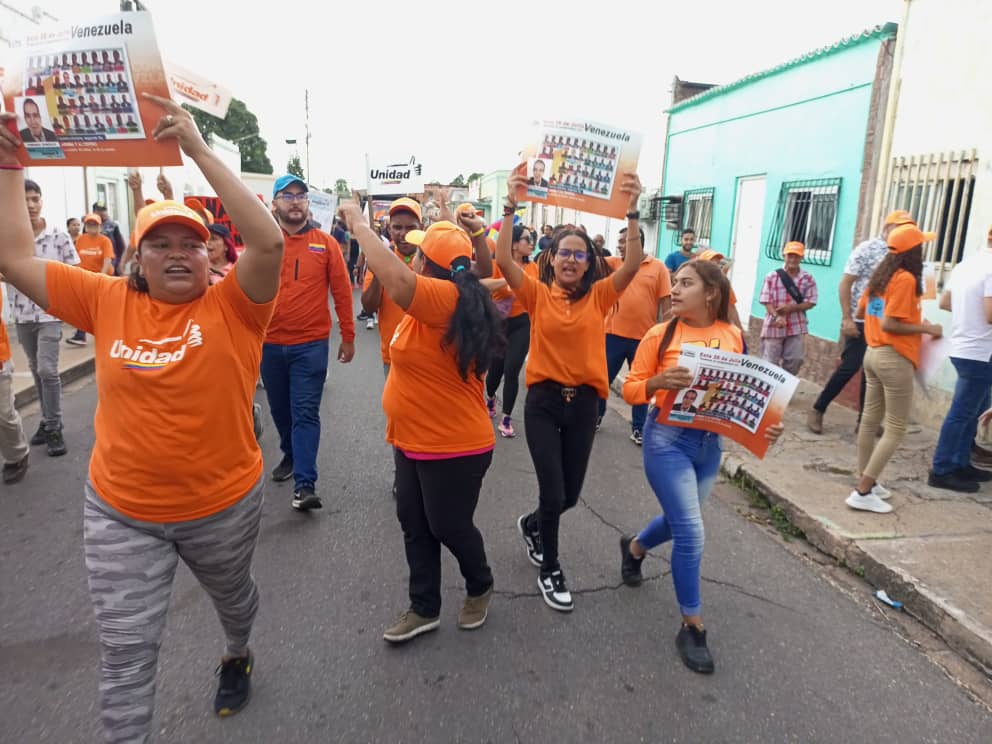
[614,377,992,676]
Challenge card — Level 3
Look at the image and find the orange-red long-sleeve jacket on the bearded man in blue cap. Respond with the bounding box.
[265,223,355,346]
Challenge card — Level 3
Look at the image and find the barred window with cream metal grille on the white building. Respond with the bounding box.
[885,150,978,284]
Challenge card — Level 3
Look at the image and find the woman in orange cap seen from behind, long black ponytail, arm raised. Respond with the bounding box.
[340,202,503,643]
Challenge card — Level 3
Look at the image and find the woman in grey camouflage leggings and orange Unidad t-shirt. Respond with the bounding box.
[0,96,283,741]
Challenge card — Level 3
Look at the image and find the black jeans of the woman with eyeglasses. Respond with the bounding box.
[524,382,599,572]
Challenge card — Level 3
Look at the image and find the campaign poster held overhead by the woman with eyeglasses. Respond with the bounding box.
[517,119,641,218]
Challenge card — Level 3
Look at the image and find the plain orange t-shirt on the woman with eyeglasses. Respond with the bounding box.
[514,273,620,398]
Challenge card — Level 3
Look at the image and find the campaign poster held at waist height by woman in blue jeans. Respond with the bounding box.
[658,344,799,458]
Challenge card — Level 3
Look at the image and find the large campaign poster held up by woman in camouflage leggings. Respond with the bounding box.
[0,12,182,167]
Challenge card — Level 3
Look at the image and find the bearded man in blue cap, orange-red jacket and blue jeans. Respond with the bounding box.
[261,175,355,511]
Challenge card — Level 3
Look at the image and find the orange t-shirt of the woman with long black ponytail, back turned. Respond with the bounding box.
[382,276,496,454]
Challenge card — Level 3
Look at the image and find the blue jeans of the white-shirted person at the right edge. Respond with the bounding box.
[933,357,992,475]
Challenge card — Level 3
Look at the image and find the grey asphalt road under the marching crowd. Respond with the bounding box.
[0,316,992,744]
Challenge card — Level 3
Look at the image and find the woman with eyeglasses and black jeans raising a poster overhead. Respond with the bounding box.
[496,165,644,612]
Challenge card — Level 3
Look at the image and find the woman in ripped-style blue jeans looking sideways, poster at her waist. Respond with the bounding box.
[620,261,782,674]
